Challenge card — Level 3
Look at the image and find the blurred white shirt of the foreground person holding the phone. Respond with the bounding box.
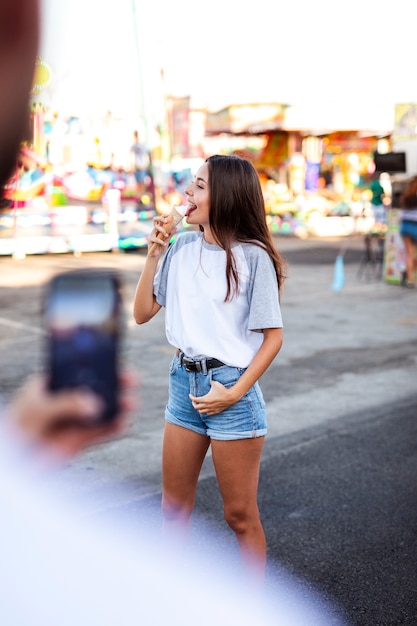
[0,428,342,626]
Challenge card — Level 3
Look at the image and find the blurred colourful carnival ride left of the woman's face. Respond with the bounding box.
[0,147,162,256]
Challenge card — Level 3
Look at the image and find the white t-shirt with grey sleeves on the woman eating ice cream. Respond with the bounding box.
[154,232,282,368]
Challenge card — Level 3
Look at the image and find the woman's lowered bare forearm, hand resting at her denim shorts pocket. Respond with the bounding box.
[190,328,283,415]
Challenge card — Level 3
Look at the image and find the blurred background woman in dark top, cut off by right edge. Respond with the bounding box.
[400,176,417,288]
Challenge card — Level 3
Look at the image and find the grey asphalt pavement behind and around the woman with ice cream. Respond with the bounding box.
[0,232,417,626]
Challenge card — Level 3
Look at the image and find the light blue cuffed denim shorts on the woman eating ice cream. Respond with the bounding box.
[165,355,267,441]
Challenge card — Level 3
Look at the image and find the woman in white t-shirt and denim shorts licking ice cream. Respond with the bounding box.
[134,155,284,578]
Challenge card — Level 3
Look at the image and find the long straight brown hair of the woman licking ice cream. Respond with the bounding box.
[206,154,285,301]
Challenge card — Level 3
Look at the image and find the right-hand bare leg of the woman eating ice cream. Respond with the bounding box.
[211,437,266,581]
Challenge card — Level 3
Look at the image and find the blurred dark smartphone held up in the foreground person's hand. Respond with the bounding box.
[44,269,123,422]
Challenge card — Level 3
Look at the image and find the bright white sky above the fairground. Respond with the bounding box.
[40,0,417,129]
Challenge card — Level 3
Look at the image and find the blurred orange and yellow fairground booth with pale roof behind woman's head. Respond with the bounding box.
[206,103,390,236]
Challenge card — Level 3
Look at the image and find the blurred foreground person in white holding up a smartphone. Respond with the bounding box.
[0,0,341,626]
